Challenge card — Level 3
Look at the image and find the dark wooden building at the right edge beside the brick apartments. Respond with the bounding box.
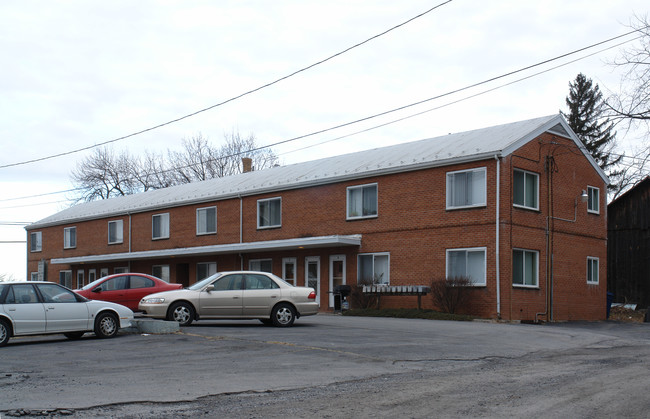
[607,177,650,308]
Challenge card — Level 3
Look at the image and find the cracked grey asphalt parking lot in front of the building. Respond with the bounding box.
[0,314,650,418]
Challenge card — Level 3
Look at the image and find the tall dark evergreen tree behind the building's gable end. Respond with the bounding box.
[560,73,623,190]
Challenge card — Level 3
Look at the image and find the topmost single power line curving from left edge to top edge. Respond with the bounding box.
[0,0,453,169]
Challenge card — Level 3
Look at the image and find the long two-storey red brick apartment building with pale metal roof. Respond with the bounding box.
[26,115,608,321]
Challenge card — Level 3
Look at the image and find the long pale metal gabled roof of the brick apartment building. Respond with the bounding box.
[26,115,608,230]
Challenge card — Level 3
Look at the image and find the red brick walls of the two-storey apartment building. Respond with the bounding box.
[24,134,606,320]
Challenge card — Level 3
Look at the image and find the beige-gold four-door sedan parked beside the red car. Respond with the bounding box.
[138,271,318,327]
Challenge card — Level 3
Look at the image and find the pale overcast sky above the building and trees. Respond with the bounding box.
[0,0,648,279]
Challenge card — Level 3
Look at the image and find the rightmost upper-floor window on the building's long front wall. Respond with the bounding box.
[447,167,487,209]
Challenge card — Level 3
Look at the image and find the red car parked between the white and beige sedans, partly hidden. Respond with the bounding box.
[75,272,183,311]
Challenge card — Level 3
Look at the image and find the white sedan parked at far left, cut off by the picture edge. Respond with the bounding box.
[0,281,133,346]
